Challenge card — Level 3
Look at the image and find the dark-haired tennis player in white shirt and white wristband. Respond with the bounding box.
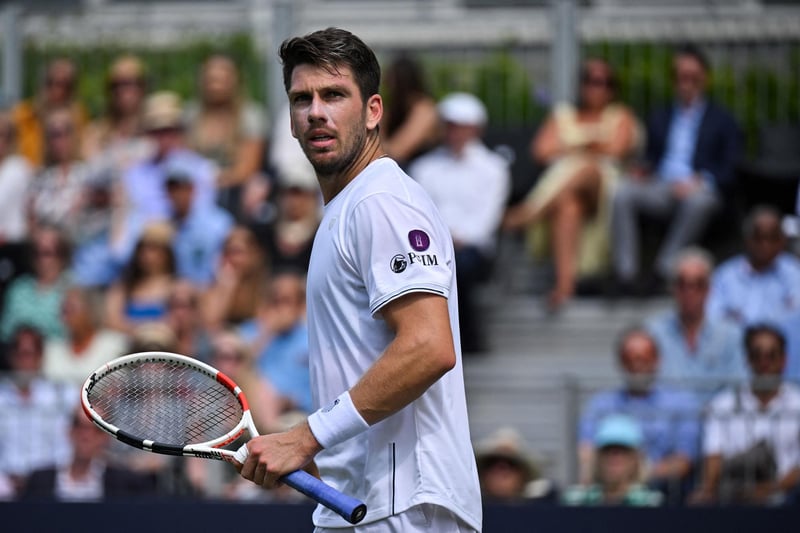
[241,28,482,532]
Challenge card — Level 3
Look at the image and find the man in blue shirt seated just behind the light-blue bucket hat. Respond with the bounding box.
[578,327,700,498]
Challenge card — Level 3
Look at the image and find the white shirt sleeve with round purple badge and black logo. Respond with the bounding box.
[345,192,454,314]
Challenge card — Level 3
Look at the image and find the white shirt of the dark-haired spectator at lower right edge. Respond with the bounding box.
[703,383,800,477]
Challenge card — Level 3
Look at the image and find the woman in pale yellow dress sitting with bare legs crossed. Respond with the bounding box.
[503,59,642,309]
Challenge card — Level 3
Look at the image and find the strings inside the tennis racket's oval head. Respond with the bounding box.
[88,361,242,446]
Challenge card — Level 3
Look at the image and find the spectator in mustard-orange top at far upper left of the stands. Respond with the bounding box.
[12,58,88,168]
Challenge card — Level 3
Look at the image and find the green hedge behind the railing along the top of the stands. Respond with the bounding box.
[24,34,800,152]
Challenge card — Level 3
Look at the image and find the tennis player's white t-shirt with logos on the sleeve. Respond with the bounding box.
[308,158,482,530]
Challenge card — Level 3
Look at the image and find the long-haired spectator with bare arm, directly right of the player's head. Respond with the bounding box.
[380,54,442,167]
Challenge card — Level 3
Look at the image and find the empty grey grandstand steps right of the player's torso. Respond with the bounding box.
[464,239,669,484]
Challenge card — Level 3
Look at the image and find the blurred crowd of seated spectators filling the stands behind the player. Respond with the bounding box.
[0,40,800,506]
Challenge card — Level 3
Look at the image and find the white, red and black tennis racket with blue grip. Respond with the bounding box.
[81,352,367,524]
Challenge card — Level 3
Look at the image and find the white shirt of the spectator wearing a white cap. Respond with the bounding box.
[408,140,511,253]
